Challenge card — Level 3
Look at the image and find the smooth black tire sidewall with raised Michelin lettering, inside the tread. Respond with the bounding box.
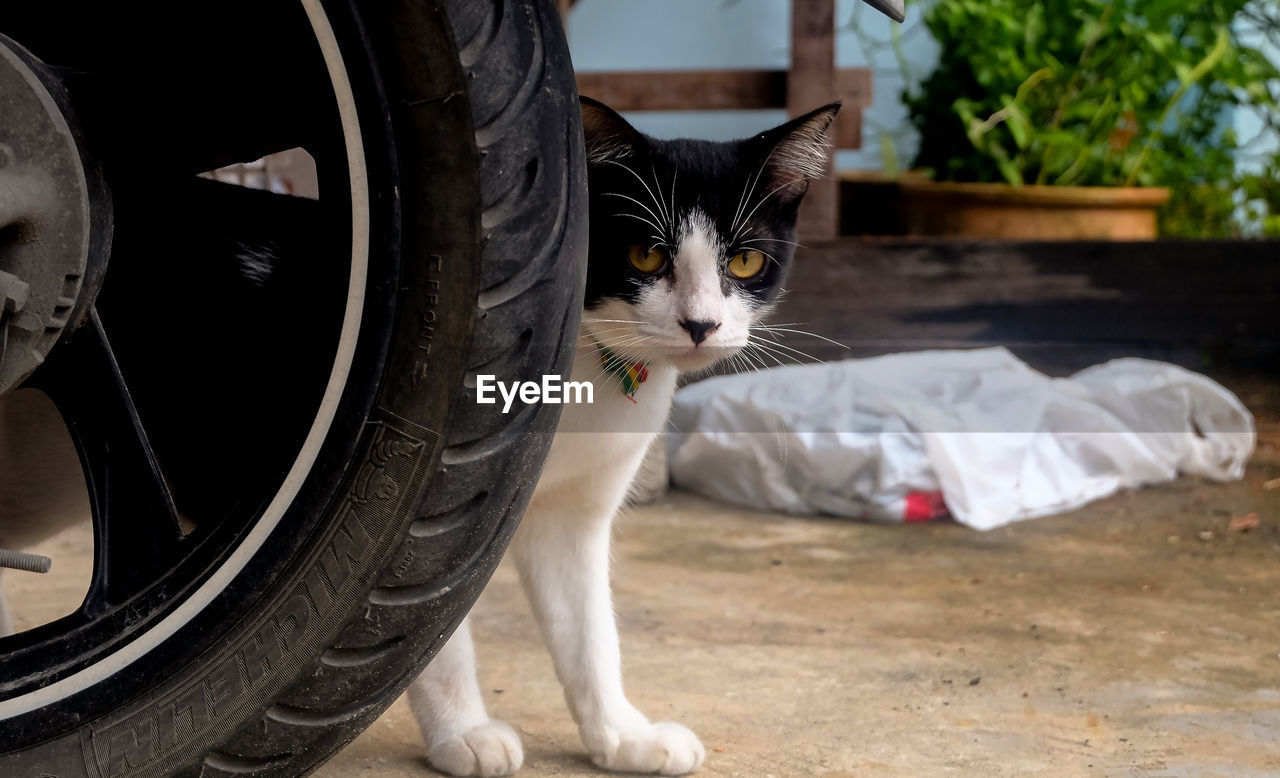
[0,0,496,778]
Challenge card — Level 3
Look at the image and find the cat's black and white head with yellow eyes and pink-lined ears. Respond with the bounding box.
[580,97,840,371]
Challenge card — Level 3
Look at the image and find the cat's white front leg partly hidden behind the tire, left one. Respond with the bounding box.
[408,618,525,775]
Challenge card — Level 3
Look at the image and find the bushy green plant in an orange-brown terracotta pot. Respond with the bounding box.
[902,0,1280,239]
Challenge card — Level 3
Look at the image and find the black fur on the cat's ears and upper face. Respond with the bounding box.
[582,97,838,310]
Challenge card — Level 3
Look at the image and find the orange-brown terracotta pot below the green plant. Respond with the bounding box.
[901,180,1169,241]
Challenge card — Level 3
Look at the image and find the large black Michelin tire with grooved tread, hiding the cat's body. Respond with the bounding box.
[0,0,586,778]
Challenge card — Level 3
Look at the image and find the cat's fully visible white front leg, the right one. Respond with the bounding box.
[513,491,707,775]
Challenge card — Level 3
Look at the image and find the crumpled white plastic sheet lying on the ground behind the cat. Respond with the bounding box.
[668,348,1256,530]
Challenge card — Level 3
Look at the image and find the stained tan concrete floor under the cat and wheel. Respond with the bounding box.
[4,425,1280,778]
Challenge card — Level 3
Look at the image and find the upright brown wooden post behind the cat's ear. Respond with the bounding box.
[787,0,841,241]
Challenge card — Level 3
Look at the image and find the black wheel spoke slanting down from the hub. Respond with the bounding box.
[29,311,182,610]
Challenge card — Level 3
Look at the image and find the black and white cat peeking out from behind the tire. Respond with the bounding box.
[408,97,840,775]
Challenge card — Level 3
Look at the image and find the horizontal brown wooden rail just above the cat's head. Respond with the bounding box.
[577,70,787,111]
